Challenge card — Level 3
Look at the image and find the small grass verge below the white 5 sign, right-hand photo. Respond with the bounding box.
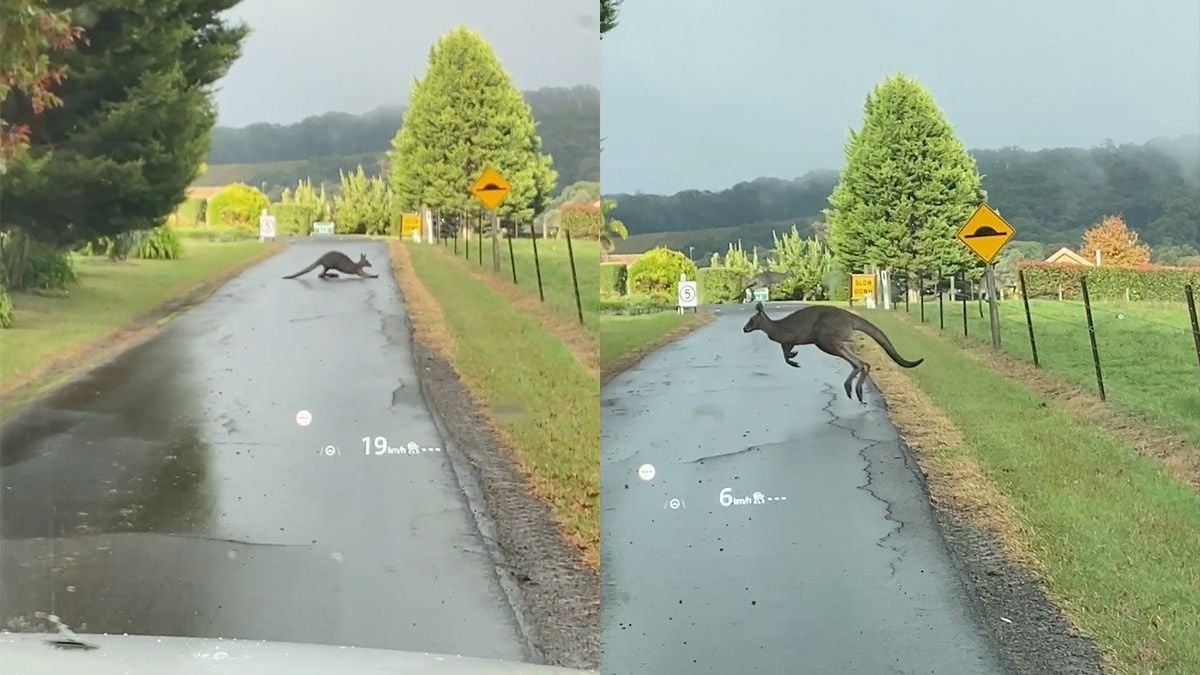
[600,312,713,382]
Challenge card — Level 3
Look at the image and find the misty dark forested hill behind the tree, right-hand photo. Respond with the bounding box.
[608,136,1200,257]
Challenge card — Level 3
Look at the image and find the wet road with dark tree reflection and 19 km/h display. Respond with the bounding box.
[0,241,524,659]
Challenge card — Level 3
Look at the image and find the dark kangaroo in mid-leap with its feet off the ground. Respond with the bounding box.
[742,303,925,402]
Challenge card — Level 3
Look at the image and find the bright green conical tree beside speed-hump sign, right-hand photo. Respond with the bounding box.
[826,73,986,274]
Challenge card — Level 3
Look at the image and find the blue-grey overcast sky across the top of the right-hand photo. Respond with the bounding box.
[600,0,1200,193]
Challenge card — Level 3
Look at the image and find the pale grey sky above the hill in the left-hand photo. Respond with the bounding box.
[216,0,600,126]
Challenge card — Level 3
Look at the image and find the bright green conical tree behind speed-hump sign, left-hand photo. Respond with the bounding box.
[389,26,557,260]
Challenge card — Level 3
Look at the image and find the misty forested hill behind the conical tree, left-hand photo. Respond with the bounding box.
[197,86,609,191]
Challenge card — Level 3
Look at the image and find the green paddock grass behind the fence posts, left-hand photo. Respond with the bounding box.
[434,238,600,333]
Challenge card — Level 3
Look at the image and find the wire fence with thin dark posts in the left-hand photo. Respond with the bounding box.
[424,207,600,330]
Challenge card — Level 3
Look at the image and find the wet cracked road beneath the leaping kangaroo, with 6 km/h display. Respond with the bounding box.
[601,305,1001,675]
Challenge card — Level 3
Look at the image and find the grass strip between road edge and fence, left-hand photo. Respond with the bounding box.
[406,243,600,562]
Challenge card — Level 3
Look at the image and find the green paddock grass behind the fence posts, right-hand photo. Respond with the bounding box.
[899,298,1200,444]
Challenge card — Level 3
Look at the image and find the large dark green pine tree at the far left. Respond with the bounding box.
[0,0,246,244]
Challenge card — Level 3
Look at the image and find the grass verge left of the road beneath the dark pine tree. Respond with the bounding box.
[0,240,263,386]
